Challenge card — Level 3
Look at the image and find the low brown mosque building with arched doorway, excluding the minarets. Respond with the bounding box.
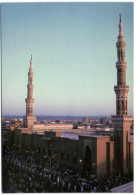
[14,128,114,176]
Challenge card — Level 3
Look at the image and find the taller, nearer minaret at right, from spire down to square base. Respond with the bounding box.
[112,14,133,174]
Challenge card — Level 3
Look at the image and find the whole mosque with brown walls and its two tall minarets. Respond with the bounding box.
[14,15,134,176]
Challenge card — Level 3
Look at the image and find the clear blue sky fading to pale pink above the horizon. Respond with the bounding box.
[1,2,134,116]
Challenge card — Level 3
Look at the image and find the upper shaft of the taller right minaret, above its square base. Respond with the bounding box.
[114,14,129,115]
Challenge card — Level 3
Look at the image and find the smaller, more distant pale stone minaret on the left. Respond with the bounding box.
[24,55,36,129]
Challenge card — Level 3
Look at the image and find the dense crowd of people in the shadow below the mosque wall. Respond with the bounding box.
[2,146,133,193]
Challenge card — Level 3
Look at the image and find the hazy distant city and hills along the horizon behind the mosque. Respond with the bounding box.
[2,115,112,129]
